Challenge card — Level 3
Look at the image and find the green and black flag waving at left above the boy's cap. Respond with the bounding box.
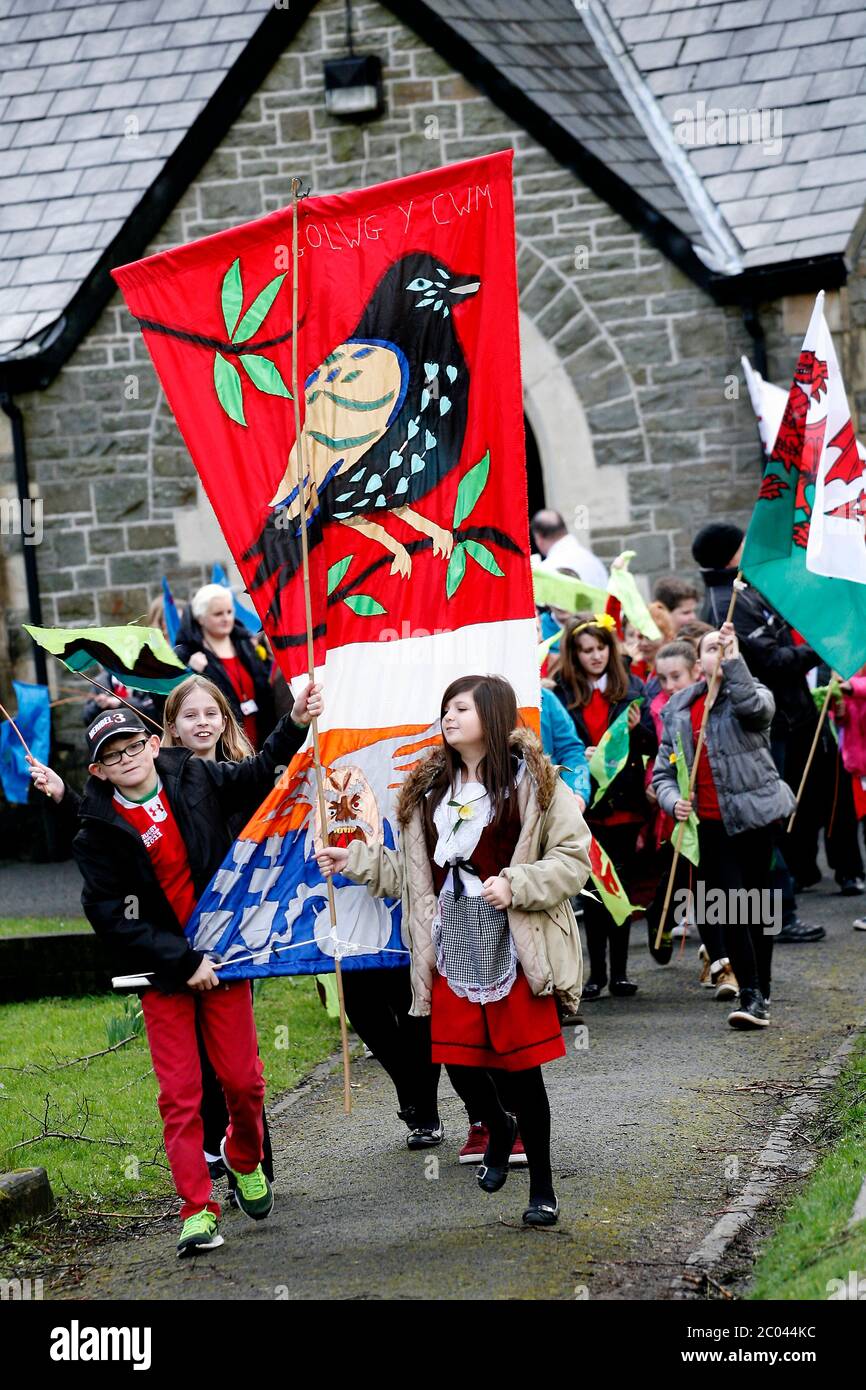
[24,623,192,695]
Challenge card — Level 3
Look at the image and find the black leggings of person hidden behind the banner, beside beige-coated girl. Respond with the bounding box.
[343,966,439,1129]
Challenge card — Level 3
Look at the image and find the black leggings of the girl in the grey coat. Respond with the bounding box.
[696,820,773,998]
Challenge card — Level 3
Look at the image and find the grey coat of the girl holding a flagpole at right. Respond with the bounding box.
[652,656,795,835]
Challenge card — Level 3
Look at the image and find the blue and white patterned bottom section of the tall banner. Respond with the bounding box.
[186,821,409,980]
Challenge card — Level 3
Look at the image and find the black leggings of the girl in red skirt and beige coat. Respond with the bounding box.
[445,1066,553,1201]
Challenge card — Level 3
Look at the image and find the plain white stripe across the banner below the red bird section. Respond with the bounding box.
[292,617,541,731]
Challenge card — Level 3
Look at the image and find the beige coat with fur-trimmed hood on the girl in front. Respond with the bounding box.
[345,728,589,1017]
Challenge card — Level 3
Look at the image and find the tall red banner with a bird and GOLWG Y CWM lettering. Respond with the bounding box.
[114,150,539,979]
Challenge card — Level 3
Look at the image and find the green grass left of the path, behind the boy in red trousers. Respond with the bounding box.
[0,976,346,1272]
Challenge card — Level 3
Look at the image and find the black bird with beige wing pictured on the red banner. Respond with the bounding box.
[245,252,481,619]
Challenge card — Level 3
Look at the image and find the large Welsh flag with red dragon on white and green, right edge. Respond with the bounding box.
[742,292,866,678]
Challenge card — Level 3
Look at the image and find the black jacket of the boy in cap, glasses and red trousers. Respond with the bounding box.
[71,716,306,992]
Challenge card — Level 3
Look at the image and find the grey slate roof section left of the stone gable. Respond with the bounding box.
[0,0,271,353]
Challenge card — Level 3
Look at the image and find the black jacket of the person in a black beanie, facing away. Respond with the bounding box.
[701,570,820,738]
